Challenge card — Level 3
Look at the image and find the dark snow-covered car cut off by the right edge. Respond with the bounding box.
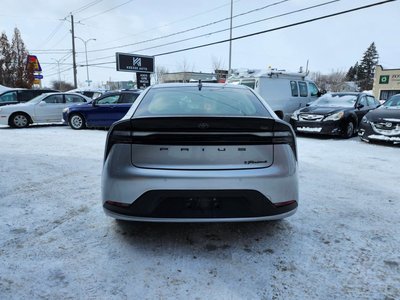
[358,94,400,144]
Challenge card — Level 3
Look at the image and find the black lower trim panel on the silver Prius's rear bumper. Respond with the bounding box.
[103,190,298,218]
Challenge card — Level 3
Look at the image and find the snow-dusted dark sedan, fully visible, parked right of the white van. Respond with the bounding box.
[290,92,380,138]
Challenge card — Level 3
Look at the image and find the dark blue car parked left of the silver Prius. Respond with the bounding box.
[63,90,141,130]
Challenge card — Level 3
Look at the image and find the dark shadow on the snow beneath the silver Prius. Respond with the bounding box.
[112,219,294,254]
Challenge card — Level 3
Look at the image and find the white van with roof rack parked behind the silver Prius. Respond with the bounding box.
[228,69,321,122]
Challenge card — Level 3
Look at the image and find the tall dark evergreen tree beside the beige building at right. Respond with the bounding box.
[358,42,379,90]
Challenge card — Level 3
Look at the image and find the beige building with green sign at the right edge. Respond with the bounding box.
[372,65,400,100]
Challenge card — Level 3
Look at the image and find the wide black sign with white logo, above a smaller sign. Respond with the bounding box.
[116,52,154,73]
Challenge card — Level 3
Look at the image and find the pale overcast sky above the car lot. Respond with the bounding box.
[0,0,400,87]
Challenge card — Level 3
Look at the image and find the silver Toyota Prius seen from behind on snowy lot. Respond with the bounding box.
[102,82,298,222]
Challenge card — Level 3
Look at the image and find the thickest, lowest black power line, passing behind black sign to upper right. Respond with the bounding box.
[84,0,396,66]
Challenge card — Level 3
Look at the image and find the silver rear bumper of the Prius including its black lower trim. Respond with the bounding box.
[102,145,298,222]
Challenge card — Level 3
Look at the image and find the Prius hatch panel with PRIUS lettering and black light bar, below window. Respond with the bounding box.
[103,117,295,170]
